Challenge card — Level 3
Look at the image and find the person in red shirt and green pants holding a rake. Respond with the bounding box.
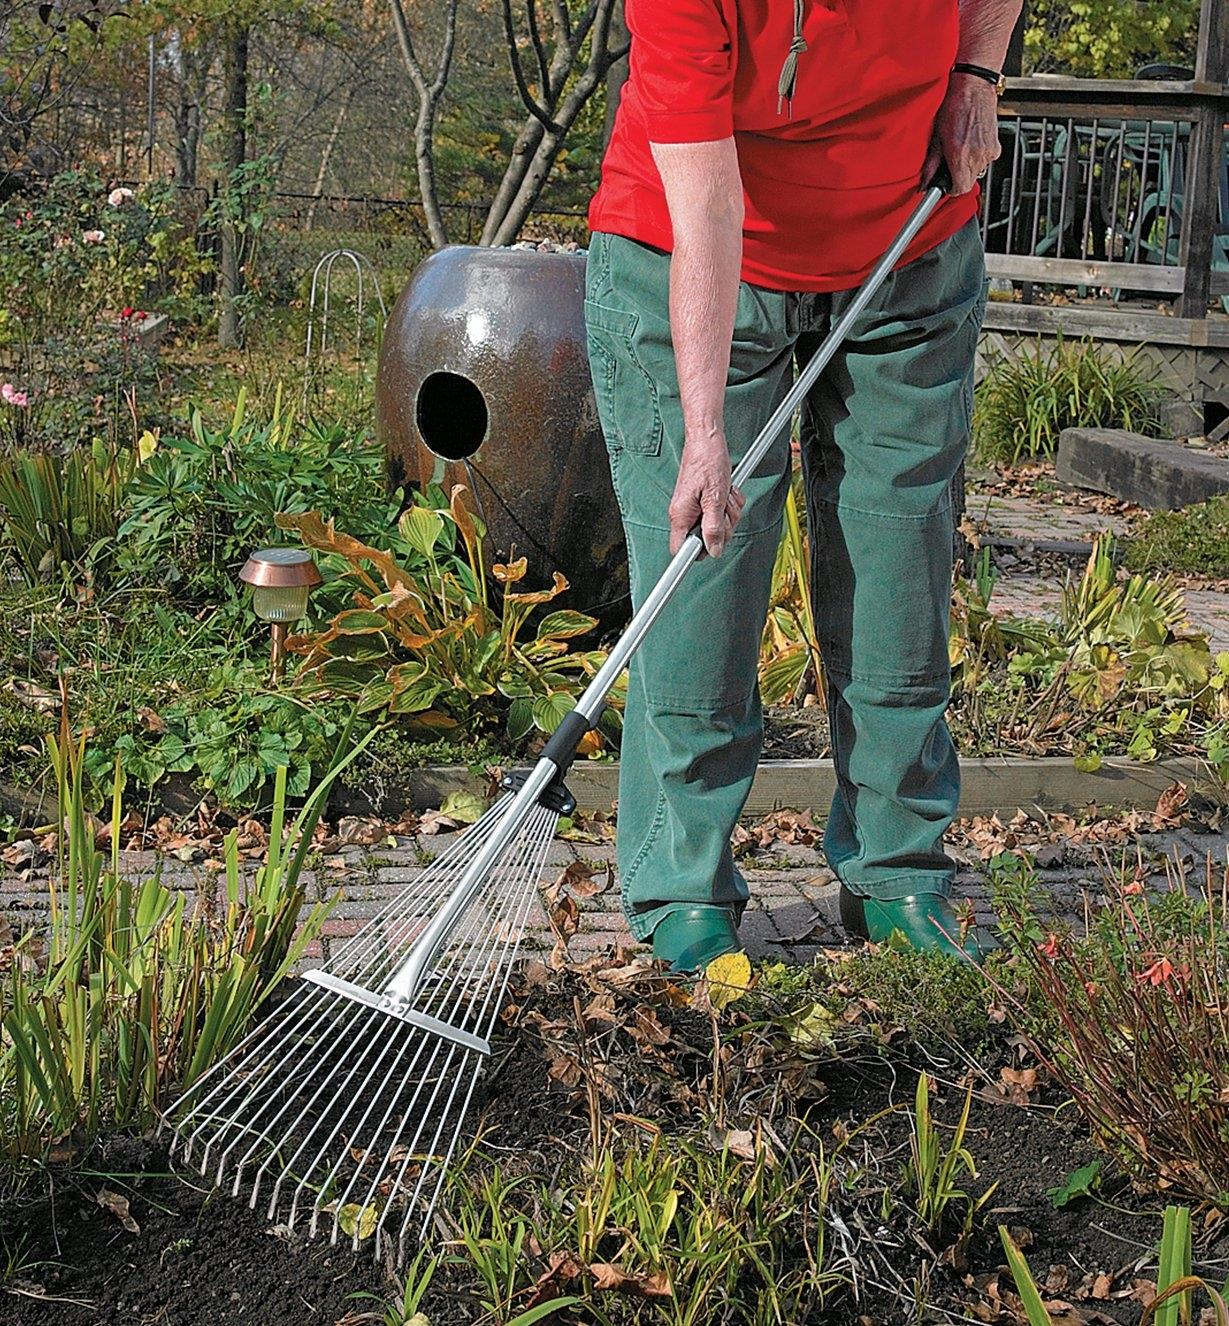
[585,0,1020,969]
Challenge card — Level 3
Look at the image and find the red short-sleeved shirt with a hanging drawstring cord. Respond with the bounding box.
[589,0,977,290]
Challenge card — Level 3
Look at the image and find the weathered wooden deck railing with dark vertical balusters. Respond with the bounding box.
[981,0,1229,322]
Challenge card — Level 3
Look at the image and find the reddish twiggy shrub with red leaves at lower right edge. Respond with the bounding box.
[990,853,1229,1205]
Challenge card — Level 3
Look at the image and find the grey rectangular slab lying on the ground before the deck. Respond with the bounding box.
[1055,428,1229,511]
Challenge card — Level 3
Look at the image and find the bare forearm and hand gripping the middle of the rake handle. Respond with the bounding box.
[652,138,742,557]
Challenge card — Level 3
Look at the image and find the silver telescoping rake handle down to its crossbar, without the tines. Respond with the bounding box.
[306,179,947,1023]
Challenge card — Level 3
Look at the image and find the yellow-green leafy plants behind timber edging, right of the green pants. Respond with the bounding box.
[949,536,1229,768]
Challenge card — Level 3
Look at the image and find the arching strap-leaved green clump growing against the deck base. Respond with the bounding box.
[973,337,1164,464]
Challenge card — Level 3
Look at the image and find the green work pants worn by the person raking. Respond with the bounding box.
[585,221,985,939]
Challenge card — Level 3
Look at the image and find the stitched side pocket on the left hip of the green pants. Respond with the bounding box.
[585,300,662,456]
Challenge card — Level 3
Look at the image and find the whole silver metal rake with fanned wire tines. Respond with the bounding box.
[172,184,944,1260]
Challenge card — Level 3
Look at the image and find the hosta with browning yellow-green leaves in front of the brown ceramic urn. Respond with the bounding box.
[278,485,618,754]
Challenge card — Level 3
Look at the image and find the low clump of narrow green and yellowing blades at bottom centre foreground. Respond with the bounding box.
[451,1138,841,1326]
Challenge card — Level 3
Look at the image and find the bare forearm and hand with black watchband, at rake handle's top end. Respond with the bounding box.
[921,0,1021,194]
